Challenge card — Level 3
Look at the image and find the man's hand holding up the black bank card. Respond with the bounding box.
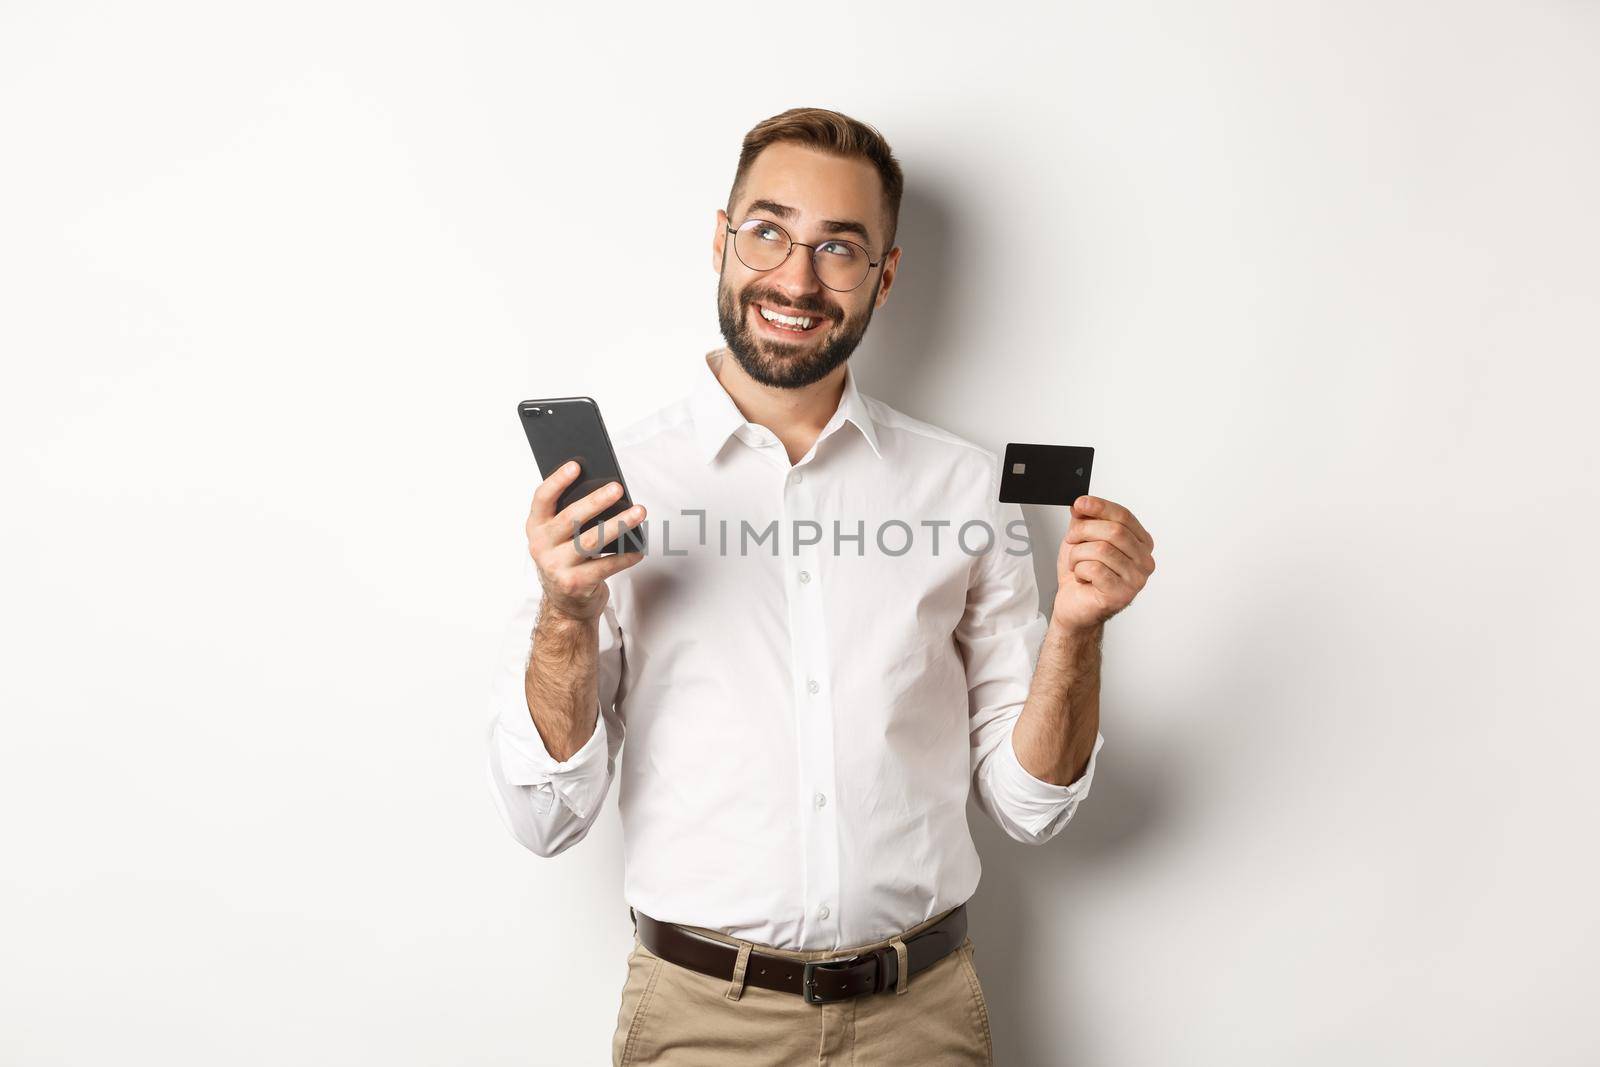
[1051,496,1155,630]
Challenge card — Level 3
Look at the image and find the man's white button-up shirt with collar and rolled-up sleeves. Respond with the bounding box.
[488,350,1104,950]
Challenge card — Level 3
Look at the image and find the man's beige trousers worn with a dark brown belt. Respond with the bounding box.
[611,912,994,1067]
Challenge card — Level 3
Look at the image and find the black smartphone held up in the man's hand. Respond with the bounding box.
[517,397,645,555]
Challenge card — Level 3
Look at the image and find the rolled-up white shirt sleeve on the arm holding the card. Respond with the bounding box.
[955,489,1106,845]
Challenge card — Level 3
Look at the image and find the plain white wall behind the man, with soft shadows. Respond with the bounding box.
[0,0,1600,1067]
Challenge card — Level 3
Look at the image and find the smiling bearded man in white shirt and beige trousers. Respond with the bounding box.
[490,109,1155,1067]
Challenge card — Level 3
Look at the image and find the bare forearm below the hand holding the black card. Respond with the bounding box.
[1011,619,1106,785]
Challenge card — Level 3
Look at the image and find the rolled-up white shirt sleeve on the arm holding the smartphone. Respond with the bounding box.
[488,558,624,856]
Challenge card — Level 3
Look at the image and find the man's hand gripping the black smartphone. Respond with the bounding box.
[526,461,645,622]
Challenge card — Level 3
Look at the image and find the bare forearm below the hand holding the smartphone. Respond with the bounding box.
[523,603,600,761]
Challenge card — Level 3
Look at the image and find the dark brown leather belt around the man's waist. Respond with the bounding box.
[627,904,966,1005]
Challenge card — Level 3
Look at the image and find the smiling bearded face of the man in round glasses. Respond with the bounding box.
[712,142,899,389]
